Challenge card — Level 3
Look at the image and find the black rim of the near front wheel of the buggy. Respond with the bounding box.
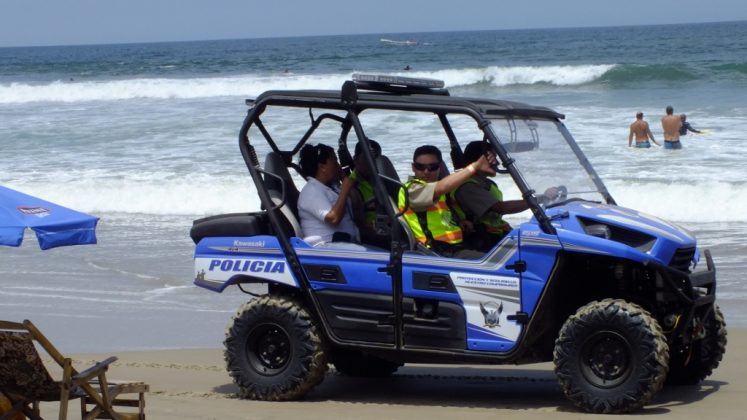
[580,331,633,388]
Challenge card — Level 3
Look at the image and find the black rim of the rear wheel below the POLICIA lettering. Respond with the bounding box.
[246,324,291,376]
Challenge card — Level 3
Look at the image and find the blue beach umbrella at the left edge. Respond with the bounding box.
[0,186,99,249]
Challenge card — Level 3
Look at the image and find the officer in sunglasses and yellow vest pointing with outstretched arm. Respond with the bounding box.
[397,145,496,259]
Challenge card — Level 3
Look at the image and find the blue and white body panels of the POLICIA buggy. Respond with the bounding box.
[195,201,697,353]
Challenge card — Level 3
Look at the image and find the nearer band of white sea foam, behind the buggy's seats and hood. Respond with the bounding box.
[4,171,747,222]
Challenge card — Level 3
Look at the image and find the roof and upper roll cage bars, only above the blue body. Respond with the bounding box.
[239,75,614,240]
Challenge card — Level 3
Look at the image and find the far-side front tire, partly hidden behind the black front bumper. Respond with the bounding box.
[666,305,726,385]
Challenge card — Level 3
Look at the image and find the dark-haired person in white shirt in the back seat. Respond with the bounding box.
[298,143,360,248]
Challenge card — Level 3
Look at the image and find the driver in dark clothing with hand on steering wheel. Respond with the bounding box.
[452,140,558,252]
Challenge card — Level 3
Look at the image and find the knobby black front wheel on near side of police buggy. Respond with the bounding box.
[553,299,669,413]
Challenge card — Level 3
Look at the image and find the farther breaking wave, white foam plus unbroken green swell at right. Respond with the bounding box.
[0,63,747,104]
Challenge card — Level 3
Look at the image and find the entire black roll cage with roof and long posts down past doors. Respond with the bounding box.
[239,75,614,342]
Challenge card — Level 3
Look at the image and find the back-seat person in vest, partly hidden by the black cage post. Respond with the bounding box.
[350,139,391,248]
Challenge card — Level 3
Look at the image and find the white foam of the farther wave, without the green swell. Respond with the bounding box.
[0,64,614,104]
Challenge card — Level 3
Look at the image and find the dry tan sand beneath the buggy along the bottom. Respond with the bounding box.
[29,329,747,420]
